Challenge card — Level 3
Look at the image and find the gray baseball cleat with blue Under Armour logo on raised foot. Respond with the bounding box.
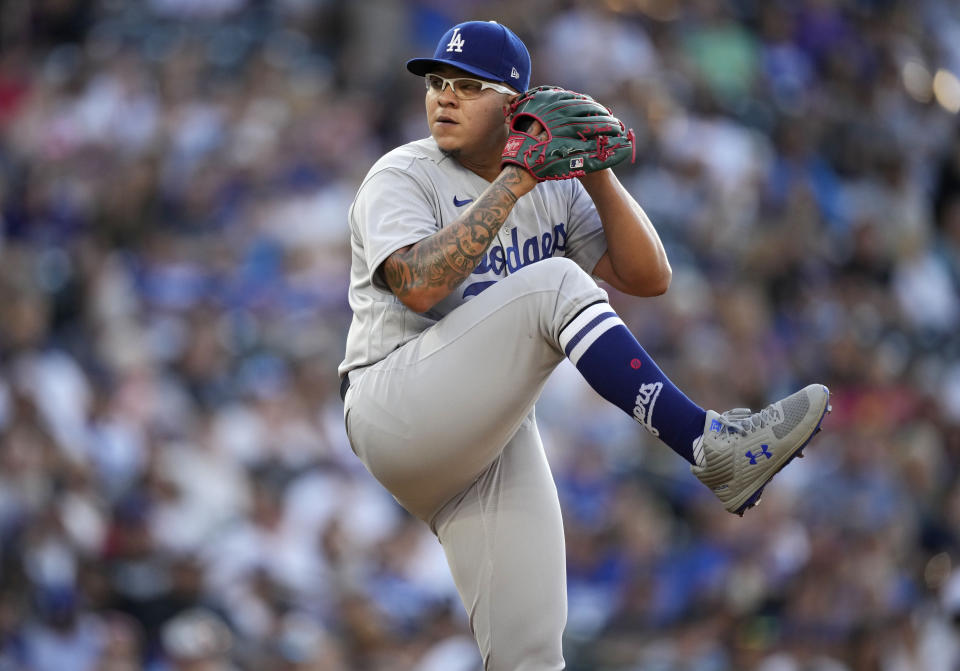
[690,384,831,516]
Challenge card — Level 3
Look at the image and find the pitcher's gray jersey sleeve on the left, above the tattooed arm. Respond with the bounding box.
[351,168,439,290]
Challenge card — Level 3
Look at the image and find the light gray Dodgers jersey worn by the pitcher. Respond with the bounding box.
[339,138,607,375]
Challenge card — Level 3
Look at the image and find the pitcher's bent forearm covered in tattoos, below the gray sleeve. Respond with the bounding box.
[380,166,537,312]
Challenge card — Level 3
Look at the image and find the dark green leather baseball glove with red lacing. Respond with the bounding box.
[500,86,636,182]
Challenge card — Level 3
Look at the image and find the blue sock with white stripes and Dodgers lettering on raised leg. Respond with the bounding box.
[560,302,707,464]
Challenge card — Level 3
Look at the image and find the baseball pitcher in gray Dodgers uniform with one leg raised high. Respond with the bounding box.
[339,21,829,671]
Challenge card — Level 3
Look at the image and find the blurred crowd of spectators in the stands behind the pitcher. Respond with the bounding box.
[0,0,960,671]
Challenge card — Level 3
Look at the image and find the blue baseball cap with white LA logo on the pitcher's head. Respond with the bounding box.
[407,21,530,91]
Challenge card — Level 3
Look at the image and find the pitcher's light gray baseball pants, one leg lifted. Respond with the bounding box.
[344,258,607,671]
